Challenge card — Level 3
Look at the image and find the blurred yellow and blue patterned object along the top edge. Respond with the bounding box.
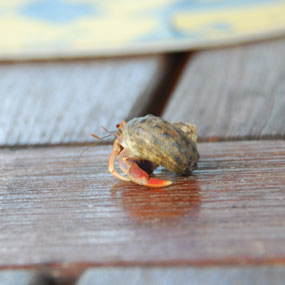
[0,0,285,59]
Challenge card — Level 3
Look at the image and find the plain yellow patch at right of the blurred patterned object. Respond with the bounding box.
[173,3,285,40]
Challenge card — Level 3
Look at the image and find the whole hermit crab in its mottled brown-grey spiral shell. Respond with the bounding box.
[93,115,199,187]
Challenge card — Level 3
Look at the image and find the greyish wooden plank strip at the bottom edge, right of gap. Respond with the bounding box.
[77,266,285,285]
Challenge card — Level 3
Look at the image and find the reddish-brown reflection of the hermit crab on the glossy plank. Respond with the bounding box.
[108,180,201,224]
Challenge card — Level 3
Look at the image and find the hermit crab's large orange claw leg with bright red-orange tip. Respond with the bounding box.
[119,148,172,187]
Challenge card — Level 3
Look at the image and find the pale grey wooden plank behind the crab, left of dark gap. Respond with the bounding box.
[0,56,170,145]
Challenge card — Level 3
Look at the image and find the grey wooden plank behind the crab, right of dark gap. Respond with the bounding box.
[163,39,285,140]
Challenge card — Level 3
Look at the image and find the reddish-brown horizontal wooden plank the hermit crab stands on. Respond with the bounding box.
[0,141,285,271]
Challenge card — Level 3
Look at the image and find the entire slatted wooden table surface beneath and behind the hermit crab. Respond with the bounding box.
[0,38,285,285]
